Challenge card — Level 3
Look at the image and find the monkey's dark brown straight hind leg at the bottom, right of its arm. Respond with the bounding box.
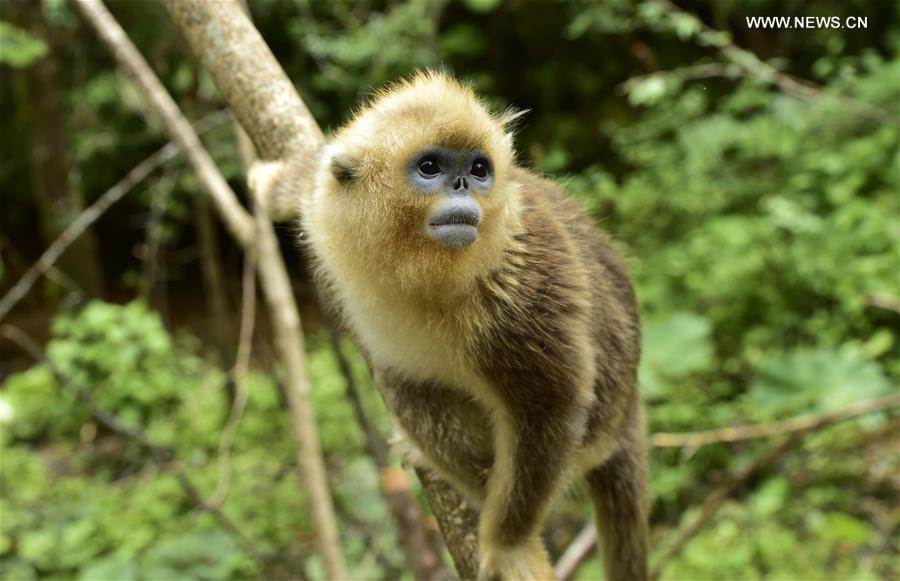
[587,440,648,581]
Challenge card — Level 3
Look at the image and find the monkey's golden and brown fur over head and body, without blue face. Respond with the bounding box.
[258,73,646,580]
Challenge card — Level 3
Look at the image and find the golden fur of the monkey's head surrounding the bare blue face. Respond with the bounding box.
[302,72,519,300]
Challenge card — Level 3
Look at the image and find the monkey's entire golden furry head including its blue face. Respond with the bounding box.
[303,72,517,292]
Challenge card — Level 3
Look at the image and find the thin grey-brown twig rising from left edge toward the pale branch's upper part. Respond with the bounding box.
[0,111,229,320]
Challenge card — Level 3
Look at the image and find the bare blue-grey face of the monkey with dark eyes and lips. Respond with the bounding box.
[406,147,494,248]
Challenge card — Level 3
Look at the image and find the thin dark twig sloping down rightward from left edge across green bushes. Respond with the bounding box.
[0,325,271,573]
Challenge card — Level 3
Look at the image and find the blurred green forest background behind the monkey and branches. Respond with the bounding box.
[0,0,900,580]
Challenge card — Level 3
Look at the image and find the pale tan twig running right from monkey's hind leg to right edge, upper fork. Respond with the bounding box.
[650,393,900,448]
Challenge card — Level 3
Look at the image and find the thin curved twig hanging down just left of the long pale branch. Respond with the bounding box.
[206,238,256,506]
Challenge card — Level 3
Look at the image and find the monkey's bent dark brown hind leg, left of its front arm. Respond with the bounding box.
[373,371,493,496]
